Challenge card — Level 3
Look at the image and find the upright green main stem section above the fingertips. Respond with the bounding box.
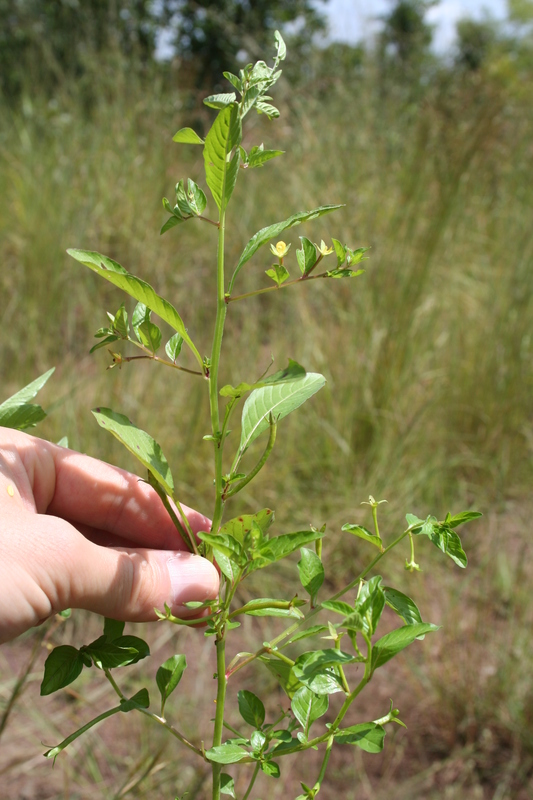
[209,208,226,533]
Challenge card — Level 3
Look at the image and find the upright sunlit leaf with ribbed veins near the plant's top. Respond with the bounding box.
[202,103,242,212]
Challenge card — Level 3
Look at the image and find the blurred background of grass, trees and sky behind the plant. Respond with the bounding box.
[0,0,533,800]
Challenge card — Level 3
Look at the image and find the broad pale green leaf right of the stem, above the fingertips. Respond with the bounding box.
[239,372,326,455]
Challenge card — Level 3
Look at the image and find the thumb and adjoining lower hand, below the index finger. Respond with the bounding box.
[0,512,219,641]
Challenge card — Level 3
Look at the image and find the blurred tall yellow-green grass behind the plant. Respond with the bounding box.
[0,54,533,800]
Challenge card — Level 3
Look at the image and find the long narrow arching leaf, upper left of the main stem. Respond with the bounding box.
[67,249,203,366]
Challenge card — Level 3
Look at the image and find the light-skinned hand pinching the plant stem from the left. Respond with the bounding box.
[0,427,219,643]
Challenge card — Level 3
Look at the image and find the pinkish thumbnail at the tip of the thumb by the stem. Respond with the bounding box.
[167,553,219,615]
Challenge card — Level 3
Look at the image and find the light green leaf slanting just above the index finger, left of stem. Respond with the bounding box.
[92,408,174,496]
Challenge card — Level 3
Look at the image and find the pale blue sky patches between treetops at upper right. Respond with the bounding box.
[325,0,506,53]
